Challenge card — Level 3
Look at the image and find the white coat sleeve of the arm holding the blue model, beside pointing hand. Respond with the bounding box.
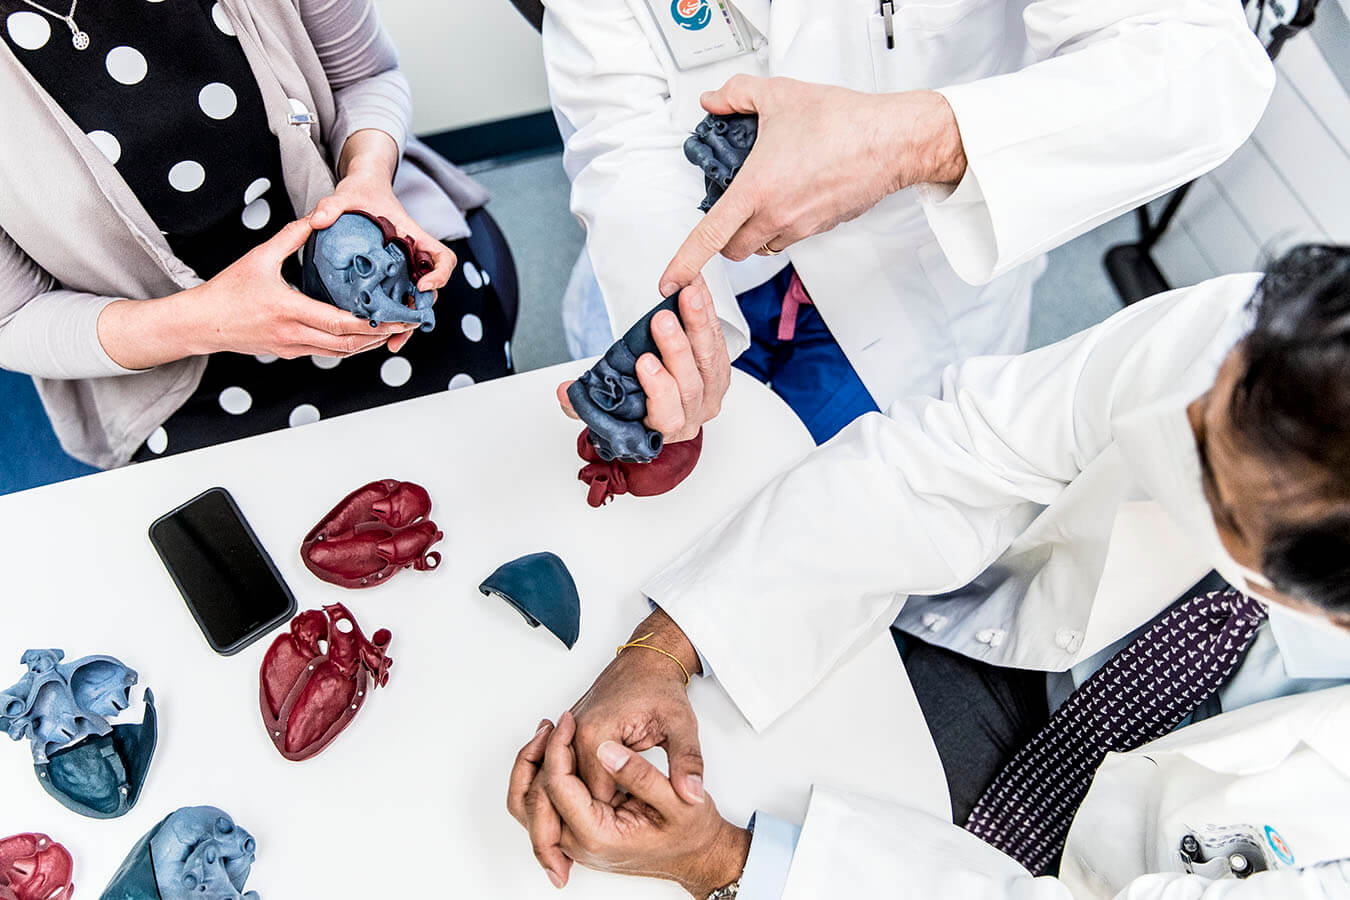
[544,0,749,359]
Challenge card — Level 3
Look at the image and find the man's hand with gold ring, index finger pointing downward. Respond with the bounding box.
[660,76,965,297]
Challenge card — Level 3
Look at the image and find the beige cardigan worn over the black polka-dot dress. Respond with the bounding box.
[0,0,487,468]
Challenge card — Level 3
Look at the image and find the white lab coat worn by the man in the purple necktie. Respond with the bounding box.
[645,274,1350,900]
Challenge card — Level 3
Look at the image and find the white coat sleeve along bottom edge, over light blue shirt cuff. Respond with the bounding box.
[782,787,1350,900]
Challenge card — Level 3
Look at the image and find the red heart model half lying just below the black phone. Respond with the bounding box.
[259,603,394,762]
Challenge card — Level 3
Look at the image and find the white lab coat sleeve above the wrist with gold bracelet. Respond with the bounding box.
[644,275,1257,729]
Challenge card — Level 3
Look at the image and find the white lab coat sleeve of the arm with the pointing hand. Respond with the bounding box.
[919,0,1274,283]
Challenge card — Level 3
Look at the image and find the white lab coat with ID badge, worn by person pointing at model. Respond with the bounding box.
[544,0,1273,409]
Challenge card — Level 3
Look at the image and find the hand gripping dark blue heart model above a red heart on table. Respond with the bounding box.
[558,277,732,444]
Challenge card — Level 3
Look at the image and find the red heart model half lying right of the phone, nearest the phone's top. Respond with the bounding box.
[300,478,444,587]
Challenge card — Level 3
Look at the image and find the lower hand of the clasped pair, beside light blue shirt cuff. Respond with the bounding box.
[512,712,751,900]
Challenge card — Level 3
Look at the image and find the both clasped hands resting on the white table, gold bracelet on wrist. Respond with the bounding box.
[506,611,749,900]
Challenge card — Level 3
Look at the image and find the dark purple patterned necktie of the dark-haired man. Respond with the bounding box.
[965,588,1266,874]
